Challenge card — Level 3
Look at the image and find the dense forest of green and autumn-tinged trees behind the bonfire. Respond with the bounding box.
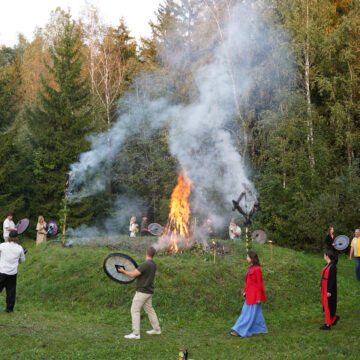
[0,0,360,248]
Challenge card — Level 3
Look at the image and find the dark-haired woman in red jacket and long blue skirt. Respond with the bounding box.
[230,251,268,337]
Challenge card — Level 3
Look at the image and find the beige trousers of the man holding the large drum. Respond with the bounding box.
[131,291,160,335]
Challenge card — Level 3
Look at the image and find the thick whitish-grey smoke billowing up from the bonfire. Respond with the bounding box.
[70,2,274,232]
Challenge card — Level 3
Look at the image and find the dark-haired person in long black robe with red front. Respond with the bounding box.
[320,249,340,330]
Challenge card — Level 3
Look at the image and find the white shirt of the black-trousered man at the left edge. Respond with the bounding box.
[0,241,25,275]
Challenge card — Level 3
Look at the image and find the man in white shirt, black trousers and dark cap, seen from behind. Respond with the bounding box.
[0,230,25,313]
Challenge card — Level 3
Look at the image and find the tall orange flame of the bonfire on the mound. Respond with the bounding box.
[163,170,192,252]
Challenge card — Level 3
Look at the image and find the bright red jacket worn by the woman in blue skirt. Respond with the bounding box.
[244,265,266,305]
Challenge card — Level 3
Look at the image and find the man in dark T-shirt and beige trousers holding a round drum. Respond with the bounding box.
[118,246,161,339]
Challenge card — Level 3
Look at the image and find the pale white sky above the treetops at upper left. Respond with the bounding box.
[0,0,161,46]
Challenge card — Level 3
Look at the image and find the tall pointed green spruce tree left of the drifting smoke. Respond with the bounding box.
[28,10,94,225]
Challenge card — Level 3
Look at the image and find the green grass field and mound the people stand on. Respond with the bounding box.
[0,238,360,360]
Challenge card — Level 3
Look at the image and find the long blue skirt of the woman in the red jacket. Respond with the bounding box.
[231,301,268,337]
